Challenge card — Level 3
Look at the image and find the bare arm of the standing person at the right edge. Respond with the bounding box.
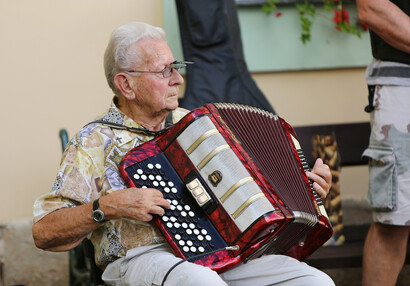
[356,0,410,54]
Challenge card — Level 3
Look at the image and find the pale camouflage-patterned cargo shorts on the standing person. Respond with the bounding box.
[363,86,410,225]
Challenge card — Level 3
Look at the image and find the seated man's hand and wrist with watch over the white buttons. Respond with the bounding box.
[100,188,170,221]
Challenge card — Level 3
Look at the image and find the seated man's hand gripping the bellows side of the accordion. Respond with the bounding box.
[306,159,332,199]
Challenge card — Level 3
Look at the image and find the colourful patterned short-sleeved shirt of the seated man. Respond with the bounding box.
[33,99,187,268]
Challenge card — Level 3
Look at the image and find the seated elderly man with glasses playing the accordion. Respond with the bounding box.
[33,23,333,286]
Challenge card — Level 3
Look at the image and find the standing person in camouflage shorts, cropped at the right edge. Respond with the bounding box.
[357,0,410,286]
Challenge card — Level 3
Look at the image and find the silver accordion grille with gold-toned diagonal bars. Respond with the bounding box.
[177,116,275,231]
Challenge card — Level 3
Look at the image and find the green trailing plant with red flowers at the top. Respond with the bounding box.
[262,0,368,44]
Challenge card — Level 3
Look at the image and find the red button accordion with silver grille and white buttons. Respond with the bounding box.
[120,103,333,273]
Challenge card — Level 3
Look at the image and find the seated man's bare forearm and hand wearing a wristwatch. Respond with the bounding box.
[33,188,170,251]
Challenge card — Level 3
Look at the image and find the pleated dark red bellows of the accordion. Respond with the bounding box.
[215,103,316,214]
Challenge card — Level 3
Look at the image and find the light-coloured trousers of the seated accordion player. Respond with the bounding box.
[102,245,335,286]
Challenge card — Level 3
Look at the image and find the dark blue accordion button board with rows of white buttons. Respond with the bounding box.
[127,154,226,257]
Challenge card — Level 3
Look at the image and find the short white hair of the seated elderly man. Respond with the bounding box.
[104,22,165,94]
